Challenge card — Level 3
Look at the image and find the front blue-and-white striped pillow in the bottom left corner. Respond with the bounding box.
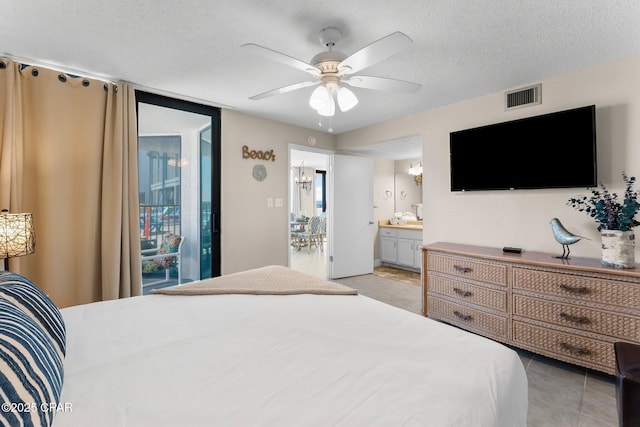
[0,298,63,426]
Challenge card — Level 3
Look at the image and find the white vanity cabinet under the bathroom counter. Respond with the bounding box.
[379,227,422,270]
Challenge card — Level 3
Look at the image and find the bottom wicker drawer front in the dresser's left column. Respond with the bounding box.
[427,296,507,340]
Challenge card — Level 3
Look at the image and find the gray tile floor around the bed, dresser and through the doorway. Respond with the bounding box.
[291,249,618,427]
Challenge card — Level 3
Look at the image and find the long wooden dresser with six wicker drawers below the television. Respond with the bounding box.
[422,243,640,374]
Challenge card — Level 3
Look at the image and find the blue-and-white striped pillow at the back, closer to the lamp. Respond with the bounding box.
[0,271,66,360]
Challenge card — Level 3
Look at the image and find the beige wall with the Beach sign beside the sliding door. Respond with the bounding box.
[221,110,335,274]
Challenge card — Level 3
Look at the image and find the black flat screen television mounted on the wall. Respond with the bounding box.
[449,105,597,191]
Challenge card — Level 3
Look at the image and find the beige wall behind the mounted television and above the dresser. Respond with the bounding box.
[337,57,640,259]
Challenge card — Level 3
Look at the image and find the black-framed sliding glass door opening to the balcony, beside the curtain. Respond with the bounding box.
[136,91,221,294]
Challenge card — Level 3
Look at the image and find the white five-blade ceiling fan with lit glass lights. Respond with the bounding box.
[242,27,422,117]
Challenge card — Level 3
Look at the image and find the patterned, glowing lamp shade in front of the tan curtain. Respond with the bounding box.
[0,211,36,258]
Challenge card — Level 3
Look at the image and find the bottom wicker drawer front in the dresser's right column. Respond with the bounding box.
[513,321,615,373]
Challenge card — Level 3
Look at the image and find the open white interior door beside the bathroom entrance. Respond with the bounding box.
[327,154,376,279]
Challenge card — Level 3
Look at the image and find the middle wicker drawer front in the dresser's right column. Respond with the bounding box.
[513,295,640,341]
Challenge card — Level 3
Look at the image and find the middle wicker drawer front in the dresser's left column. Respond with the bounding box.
[428,275,507,314]
